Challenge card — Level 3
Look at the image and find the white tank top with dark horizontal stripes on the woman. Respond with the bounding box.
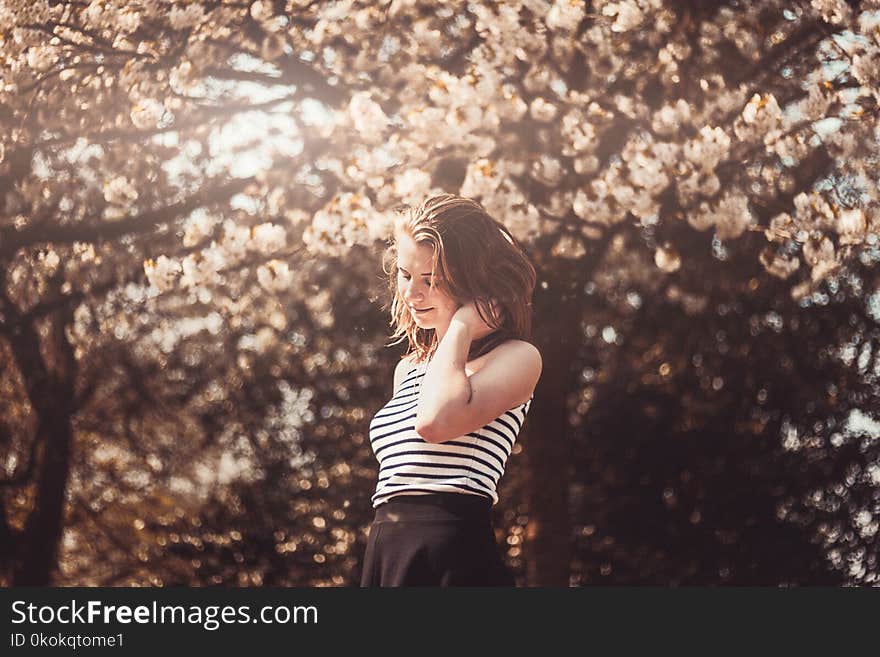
[370,363,534,508]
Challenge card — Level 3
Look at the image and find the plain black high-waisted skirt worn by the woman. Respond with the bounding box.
[361,493,516,587]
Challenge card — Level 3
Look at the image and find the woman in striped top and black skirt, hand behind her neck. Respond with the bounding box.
[361,194,541,586]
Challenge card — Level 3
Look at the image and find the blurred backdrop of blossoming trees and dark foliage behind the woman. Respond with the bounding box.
[0,0,880,587]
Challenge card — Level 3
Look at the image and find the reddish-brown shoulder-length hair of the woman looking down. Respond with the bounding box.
[382,194,536,362]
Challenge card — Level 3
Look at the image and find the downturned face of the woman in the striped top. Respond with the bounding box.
[397,233,459,334]
